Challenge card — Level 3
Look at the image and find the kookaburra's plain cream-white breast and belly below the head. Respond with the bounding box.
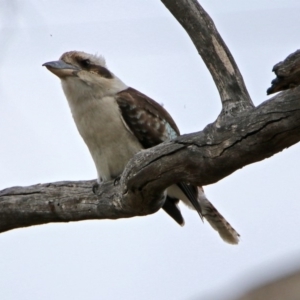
[64,78,142,181]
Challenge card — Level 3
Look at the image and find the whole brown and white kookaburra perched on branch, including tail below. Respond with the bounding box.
[43,51,240,244]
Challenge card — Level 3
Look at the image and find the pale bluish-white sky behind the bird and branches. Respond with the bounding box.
[0,0,300,300]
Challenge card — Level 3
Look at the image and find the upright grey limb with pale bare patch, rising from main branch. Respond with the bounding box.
[161,0,254,117]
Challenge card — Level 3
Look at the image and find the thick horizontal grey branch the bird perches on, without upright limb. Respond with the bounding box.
[0,87,300,232]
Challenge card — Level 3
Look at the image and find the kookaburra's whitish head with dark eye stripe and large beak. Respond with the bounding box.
[43,51,127,106]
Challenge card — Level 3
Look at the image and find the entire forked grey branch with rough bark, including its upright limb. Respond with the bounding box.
[0,0,300,232]
